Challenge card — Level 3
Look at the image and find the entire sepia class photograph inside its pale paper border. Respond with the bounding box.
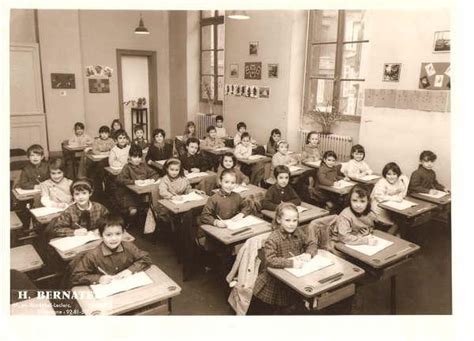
[4,3,466,339]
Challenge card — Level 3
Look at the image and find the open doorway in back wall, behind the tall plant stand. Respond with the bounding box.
[117,49,158,140]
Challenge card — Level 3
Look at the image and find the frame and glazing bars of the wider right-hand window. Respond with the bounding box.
[303,10,369,122]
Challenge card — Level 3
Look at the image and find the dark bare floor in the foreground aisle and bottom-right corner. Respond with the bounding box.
[132,216,452,315]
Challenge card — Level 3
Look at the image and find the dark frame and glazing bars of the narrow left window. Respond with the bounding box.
[199,10,225,105]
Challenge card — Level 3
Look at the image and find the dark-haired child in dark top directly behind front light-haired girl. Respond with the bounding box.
[262,165,301,211]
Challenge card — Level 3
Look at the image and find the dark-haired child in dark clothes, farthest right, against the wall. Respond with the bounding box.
[408,150,449,194]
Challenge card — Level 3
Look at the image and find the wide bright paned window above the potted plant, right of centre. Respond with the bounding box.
[304,10,369,121]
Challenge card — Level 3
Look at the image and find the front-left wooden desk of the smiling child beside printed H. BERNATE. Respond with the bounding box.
[72,265,181,315]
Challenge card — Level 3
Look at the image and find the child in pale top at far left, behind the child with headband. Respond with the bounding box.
[40,159,72,208]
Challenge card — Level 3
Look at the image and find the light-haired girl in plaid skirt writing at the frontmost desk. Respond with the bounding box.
[247,203,317,315]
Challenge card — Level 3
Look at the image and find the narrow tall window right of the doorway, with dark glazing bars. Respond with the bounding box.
[200,11,225,104]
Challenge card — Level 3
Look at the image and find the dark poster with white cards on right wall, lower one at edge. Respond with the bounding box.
[419,63,451,90]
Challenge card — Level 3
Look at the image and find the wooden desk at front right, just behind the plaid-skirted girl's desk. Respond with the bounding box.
[335,230,420,314]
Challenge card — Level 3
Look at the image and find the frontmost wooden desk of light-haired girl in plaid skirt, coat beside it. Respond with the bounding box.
[267,250,364,310]
